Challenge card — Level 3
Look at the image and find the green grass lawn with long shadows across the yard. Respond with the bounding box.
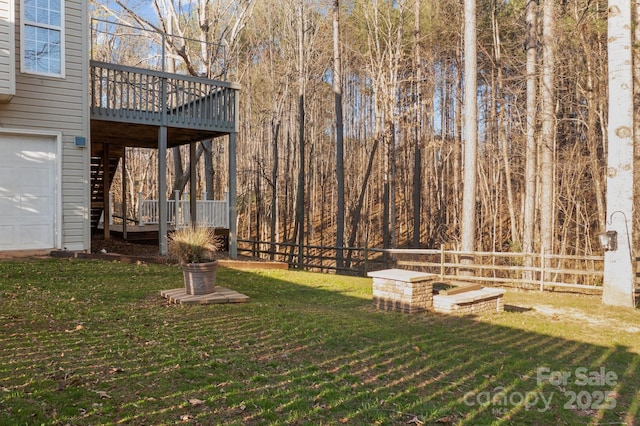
[0,259,640,425]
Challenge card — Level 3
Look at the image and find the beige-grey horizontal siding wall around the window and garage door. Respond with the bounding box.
[0,0,91,250]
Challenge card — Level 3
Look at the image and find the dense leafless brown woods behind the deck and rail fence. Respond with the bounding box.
[93,0,632,255]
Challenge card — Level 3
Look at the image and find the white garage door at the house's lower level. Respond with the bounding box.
[0,135,57,250]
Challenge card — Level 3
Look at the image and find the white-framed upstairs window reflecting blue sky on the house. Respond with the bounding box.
[21,0,64,77]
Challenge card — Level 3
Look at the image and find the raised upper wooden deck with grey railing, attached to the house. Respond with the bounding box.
[91,61,240,148]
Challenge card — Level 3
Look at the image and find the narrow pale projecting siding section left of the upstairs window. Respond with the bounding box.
[0,0,16,102]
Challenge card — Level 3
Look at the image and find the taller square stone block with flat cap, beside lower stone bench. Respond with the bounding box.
[367,269,438,313]
